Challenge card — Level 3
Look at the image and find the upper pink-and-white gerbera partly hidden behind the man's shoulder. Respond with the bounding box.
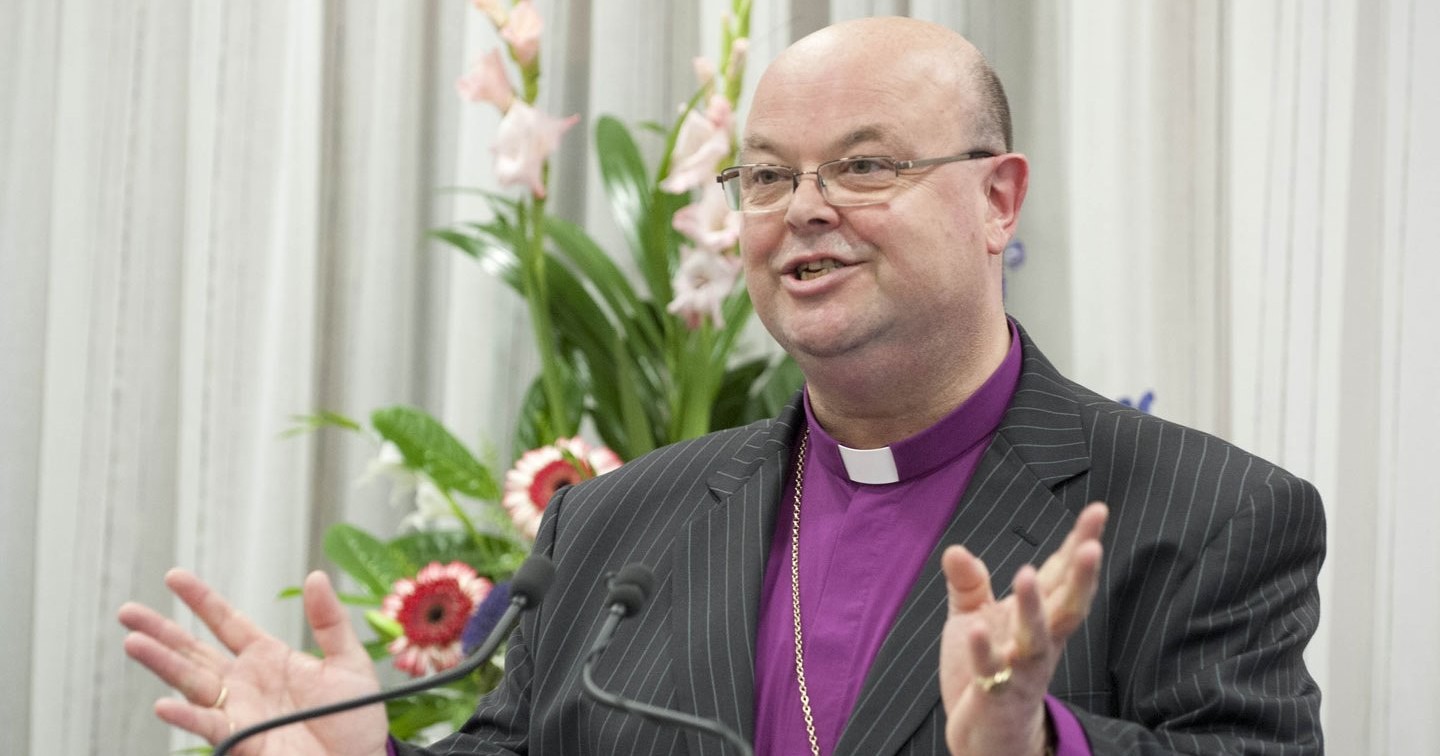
[504,436,621,539]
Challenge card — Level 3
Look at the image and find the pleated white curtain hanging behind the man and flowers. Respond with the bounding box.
[0,0,1440,755]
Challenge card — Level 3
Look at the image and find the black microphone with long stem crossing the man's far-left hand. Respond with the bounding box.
[212,554,554,756]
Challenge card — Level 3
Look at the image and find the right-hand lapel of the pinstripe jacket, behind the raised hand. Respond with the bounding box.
[835,330,1090,756]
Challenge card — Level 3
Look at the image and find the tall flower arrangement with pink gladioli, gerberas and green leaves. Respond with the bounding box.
[288,0,801,739]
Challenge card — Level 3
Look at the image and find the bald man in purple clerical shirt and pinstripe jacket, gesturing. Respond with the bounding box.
[121,13,1323,756]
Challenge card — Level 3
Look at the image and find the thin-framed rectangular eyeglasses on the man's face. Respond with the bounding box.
[716,151,995,213]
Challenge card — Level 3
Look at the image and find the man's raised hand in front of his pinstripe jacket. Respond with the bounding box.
[940,503,1109,756]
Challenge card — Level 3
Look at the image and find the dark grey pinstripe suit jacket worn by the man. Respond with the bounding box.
[406,326,1325,756]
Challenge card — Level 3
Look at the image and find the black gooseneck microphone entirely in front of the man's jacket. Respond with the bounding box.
[580,563,755,756]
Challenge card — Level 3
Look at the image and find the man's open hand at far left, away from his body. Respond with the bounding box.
[120,569,387,756]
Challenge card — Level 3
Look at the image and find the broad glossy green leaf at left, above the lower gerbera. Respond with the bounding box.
[370,406,500,501]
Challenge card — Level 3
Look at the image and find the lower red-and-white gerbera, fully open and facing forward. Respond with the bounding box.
[380,562,492,677]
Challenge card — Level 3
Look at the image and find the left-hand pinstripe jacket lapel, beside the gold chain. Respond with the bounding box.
[670,395,804,756]
